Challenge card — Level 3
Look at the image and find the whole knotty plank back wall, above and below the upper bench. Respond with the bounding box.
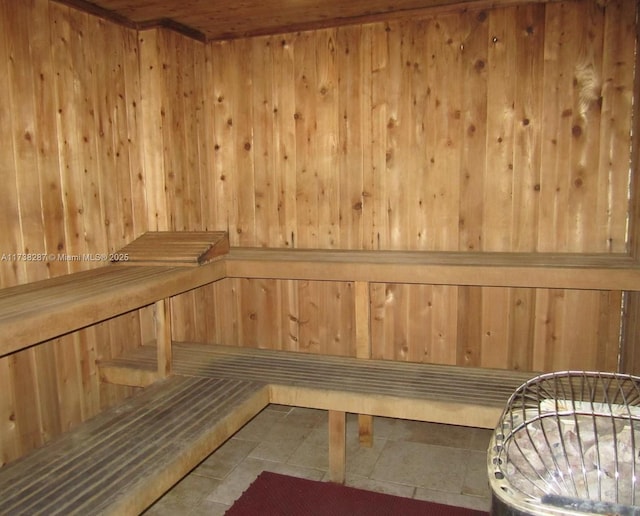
[167,1,636,370]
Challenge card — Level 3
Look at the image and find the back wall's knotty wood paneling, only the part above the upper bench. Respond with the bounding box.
[201,2,634,252]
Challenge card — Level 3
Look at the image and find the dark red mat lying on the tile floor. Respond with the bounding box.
[226,471,487,516]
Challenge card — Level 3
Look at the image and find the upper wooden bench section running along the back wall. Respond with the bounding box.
[226,248,640,291]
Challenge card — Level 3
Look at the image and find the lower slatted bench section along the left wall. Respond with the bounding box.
[0,376,269,516]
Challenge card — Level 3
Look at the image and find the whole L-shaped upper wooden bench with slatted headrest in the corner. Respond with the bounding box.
[0,231,640,356]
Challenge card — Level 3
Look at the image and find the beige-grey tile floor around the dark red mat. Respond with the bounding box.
[145,405,491,516]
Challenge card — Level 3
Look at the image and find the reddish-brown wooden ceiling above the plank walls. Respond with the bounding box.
[59,0,540,41]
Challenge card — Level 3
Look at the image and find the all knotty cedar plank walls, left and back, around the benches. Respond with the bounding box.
[0,0,635,463]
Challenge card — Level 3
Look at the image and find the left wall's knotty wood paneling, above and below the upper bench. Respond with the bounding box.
[0,0,146,463]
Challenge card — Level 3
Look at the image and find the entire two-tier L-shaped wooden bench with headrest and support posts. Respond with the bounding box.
[0,233,640,514]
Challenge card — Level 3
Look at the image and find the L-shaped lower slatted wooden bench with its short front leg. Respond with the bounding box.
[0,343,531,516]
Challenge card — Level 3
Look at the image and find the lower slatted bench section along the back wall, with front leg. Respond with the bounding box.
[101,343,533,482]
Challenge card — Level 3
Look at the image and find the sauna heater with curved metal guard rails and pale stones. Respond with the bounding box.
[487,371,640,516]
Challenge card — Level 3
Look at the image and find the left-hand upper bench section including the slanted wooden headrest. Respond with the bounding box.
[0,231,229,356]
